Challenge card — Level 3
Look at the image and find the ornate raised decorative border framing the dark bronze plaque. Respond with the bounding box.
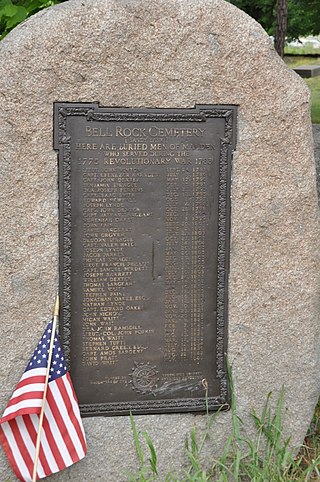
[53,102,238,416]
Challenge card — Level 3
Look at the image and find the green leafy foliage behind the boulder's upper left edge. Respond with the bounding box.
[0,0,63,39]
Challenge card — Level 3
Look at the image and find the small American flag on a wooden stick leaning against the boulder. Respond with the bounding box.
[0,321,87,482]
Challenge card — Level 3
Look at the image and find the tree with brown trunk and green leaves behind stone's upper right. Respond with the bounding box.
[229,0,320,55]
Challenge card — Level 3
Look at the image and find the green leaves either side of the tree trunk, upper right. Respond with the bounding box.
[229,0,320,40]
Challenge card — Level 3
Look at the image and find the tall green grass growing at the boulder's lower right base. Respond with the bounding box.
[128,368,320,482]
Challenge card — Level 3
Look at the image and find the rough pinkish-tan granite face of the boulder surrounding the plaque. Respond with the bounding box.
[0,0,320,482]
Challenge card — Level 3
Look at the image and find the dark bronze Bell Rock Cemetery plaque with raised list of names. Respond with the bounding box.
[54,103,236,415]
